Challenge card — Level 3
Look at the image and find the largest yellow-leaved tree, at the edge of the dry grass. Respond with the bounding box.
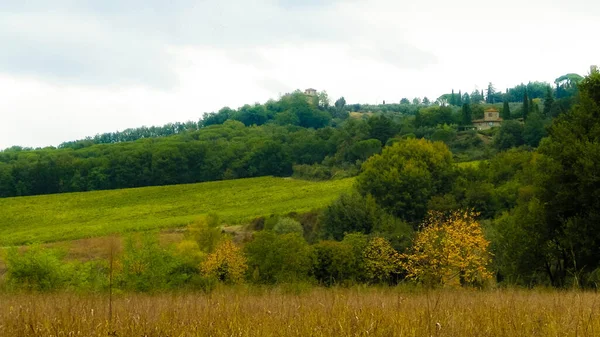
[401,211,492,286]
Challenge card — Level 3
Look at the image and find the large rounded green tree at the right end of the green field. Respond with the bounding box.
[357,139,453,222]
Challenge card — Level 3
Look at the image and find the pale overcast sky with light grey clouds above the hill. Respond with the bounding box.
[0,0,600,149]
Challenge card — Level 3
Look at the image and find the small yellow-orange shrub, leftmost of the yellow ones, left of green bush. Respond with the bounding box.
[201,240,248,283]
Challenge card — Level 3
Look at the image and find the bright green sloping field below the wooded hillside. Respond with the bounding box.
[0,177,353,246]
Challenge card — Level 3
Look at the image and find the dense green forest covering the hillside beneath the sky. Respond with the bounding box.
[0,74,581,197]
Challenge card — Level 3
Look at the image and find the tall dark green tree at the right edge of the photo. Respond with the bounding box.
[528,69,600,285]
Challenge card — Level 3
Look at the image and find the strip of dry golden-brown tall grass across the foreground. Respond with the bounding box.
[0,289,600,337]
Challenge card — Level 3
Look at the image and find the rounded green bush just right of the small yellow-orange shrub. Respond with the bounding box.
[244,231,314,284]
